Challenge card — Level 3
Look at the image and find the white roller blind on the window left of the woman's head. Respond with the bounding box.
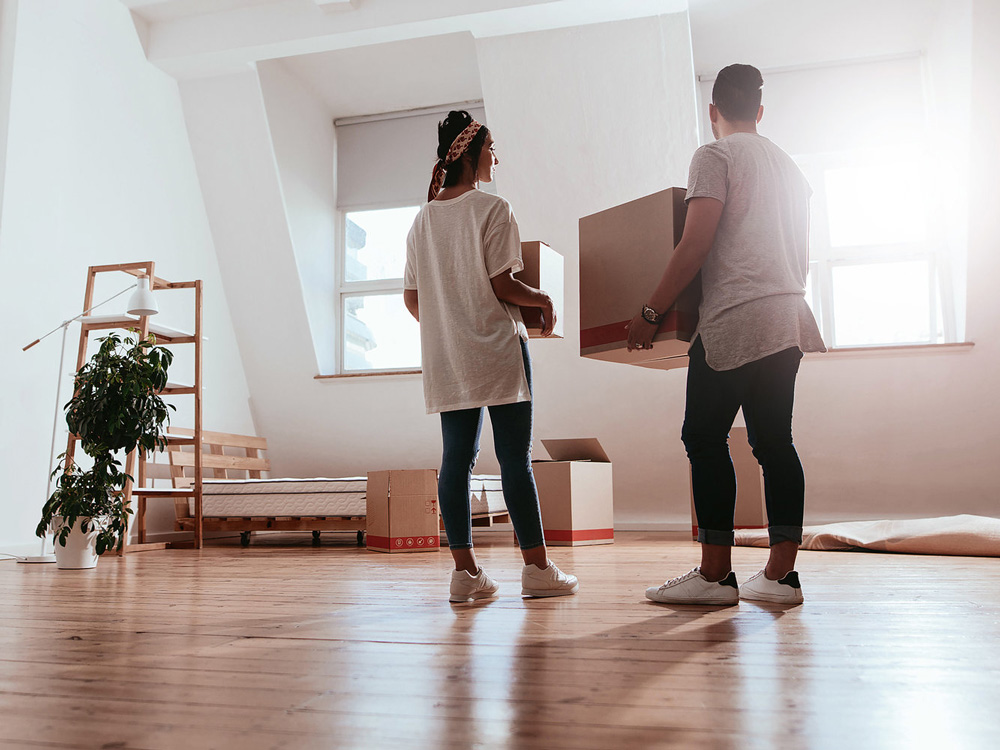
[337,107,486,211]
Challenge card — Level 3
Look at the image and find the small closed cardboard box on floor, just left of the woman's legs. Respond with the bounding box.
[365,469,441,552]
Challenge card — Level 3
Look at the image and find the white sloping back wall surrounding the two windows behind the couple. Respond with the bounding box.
[182,8,1000,527]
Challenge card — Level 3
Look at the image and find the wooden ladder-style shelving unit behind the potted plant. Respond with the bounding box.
[66,261,203,555]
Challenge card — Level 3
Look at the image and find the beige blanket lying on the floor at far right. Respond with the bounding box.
[736,515,1000,557]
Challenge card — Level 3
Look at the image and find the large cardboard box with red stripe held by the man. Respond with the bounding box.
[580,188,701,369]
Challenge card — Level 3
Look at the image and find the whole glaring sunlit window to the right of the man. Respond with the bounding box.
[796,151,950,347]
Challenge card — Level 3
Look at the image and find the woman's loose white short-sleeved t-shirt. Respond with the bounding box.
[403,190,531,414]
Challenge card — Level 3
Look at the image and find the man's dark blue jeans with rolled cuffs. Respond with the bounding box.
[681,337,805,546]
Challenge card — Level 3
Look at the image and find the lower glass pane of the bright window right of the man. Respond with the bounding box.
[833,260,930,346]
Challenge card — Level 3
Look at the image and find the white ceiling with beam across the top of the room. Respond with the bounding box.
[121,0,945,117]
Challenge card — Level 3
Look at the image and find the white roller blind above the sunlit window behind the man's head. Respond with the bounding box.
[701,56,926,155]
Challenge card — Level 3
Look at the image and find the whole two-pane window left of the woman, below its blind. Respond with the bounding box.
[340,206,420,373]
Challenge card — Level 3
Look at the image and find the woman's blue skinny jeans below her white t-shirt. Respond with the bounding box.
[438,341,545,549]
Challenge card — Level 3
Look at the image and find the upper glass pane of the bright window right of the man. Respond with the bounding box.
[824,160,927,247]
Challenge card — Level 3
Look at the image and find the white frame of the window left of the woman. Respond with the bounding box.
[334,201,422,377]
